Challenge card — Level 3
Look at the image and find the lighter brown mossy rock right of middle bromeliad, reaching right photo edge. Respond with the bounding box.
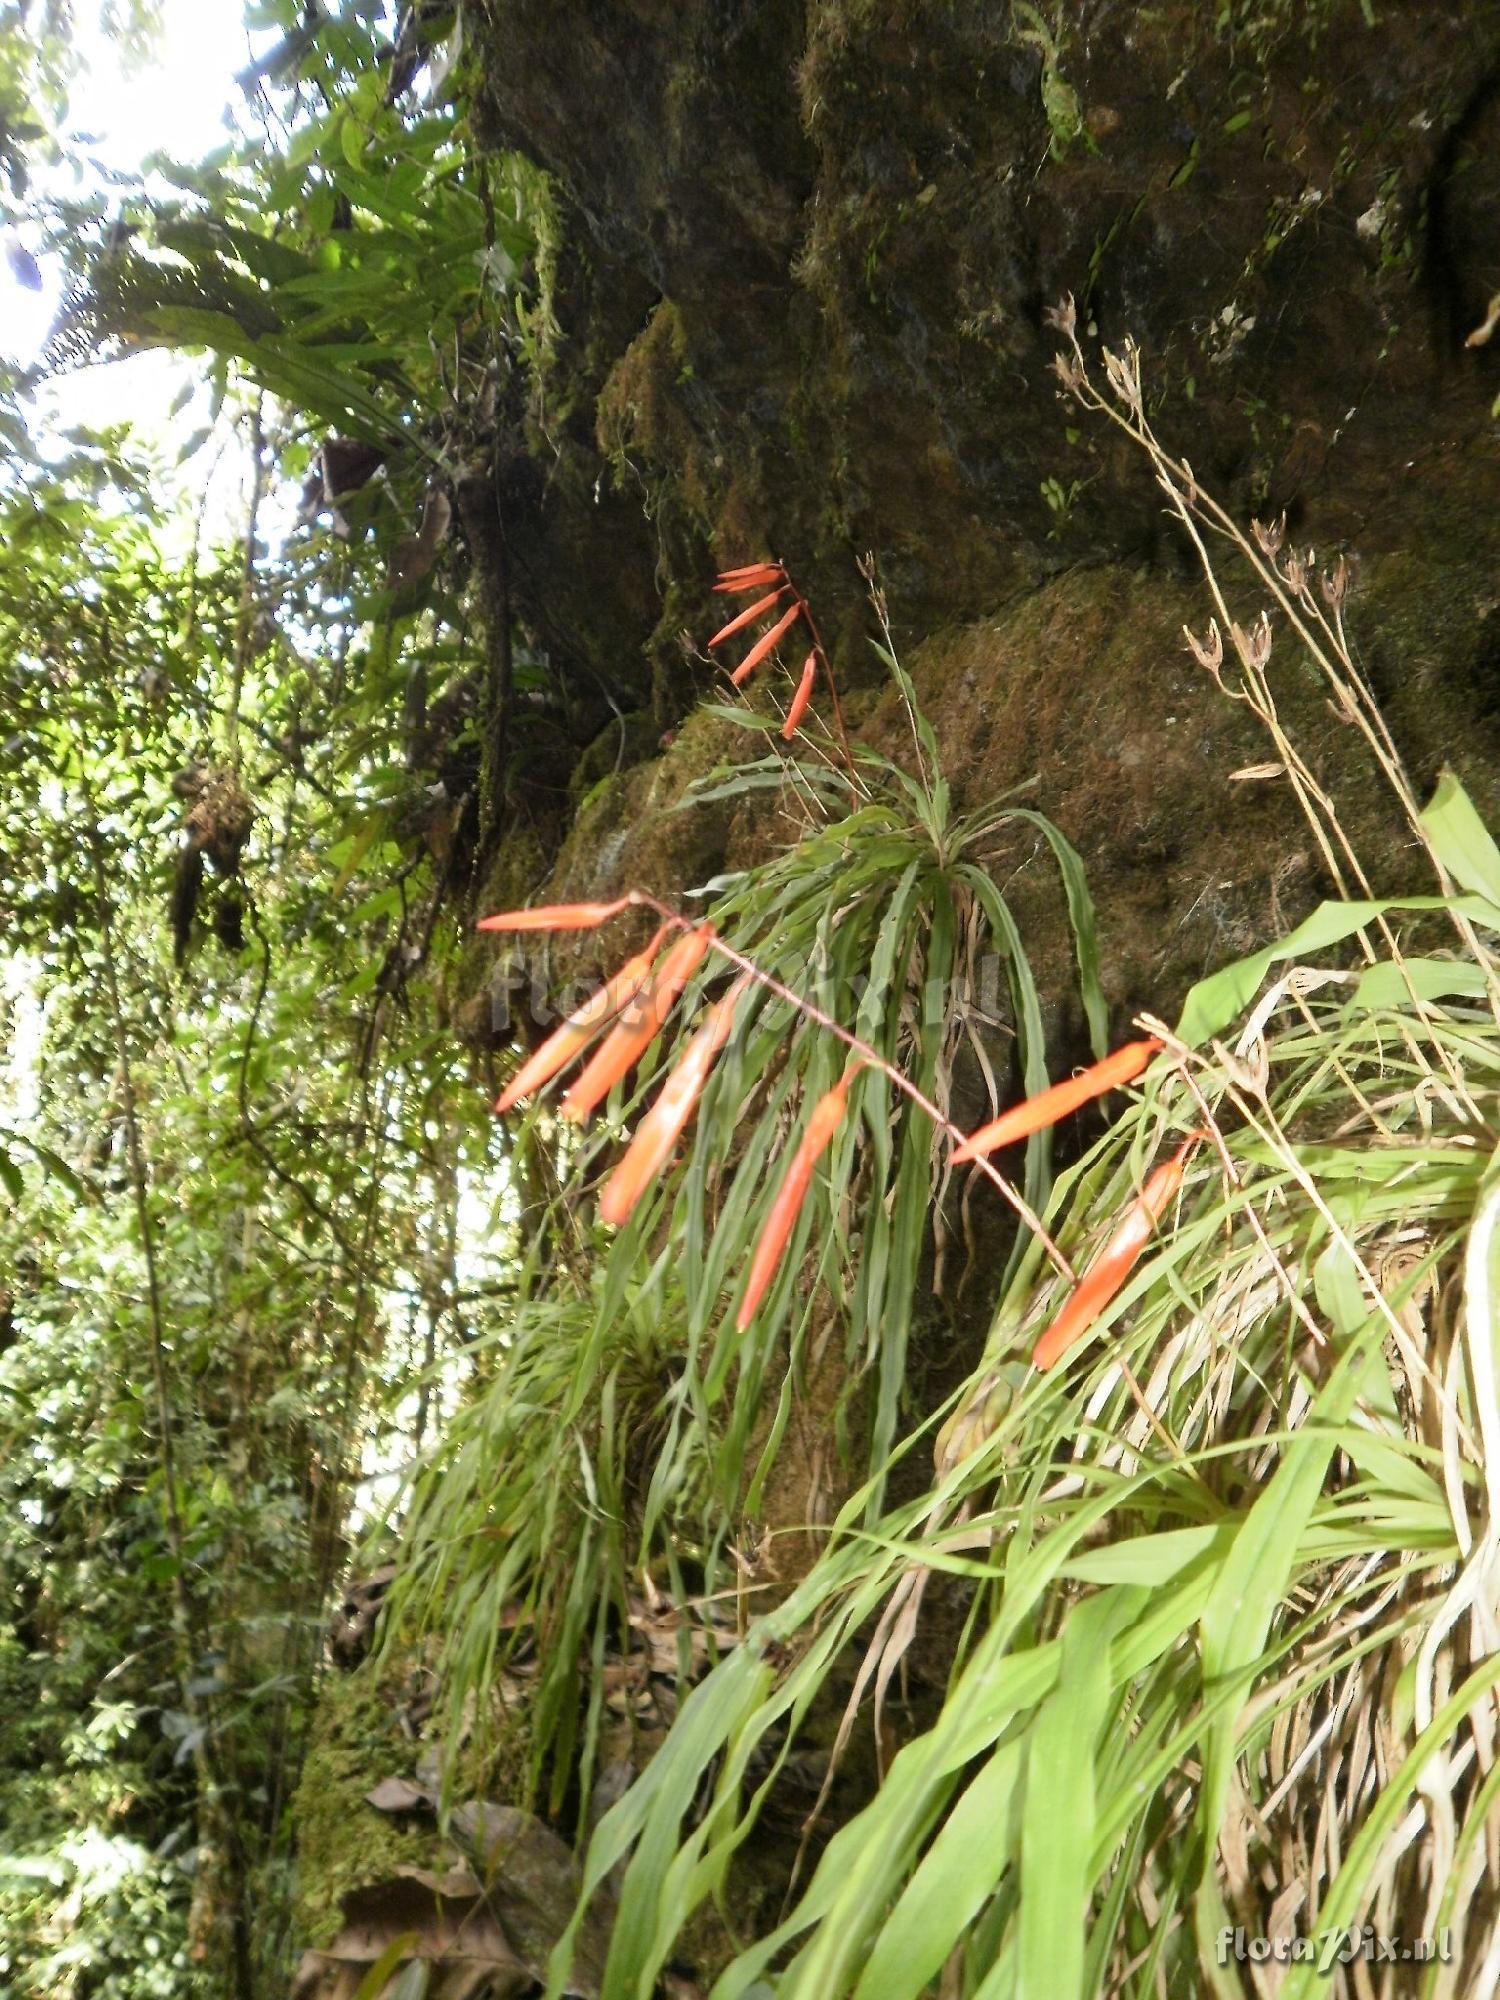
[862,448,1500,1056]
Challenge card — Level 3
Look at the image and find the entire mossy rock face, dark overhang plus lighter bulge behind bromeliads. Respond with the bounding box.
[464,0,1500,1044]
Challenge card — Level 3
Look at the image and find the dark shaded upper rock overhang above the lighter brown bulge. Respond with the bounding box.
[480,0,1500,656]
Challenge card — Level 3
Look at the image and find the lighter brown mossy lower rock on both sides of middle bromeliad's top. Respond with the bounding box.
[456,440,1500,1064]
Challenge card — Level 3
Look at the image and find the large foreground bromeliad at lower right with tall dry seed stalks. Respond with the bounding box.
[532,348,1500,2000]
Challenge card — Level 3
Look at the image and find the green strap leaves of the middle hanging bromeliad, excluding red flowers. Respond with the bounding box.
[396,656,1104,1810]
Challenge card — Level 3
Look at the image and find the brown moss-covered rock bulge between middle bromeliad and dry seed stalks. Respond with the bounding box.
[864,564,1456,1040]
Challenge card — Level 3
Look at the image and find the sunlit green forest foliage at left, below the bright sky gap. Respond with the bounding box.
[0,382,516,1992]
